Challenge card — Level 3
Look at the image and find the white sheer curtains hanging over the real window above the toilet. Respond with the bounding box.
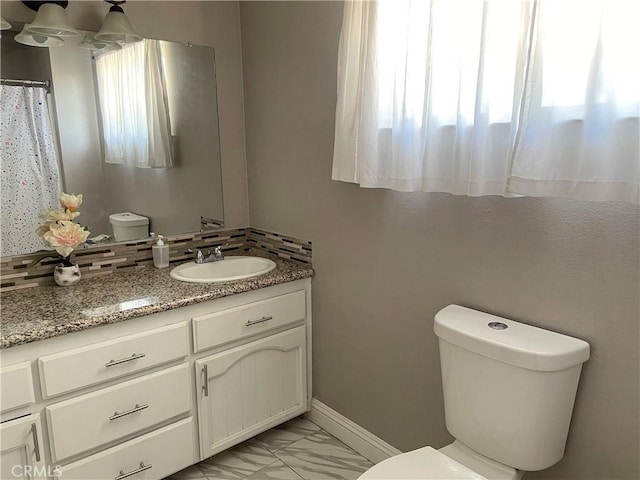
[332,0,640,203]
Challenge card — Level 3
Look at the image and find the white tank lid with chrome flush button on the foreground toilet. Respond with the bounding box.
[434,305,589,372]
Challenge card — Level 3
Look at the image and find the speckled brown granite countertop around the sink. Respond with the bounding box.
[0,257,313,348]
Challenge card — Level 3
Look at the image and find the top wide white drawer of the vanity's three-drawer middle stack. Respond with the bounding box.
[38,322,189,398]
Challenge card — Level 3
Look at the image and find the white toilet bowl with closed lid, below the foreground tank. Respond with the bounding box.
[359,441,524,480]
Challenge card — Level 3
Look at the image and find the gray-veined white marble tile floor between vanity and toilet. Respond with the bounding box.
[165,417,373,480]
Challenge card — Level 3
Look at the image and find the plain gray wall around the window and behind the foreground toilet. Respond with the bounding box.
[241,2,640,480]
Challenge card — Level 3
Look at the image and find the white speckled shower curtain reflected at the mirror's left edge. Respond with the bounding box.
[0,85,61,257]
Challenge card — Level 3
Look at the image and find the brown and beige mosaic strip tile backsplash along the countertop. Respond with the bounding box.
[0,227,312,291]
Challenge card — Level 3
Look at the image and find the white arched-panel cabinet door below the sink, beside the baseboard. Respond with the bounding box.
[195,326,307,459]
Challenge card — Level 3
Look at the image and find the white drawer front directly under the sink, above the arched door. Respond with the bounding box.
[193,290,306,352]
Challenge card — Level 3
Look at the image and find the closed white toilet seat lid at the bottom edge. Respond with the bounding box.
[359,447,487,480]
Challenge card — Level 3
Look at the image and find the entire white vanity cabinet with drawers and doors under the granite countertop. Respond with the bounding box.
[0,279,311,480]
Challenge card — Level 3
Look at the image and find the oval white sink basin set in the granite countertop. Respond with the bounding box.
[170,256,276,283]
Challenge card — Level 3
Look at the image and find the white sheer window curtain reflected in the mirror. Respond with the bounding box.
[96,39,173,168]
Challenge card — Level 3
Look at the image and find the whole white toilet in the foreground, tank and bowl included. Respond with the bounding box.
[360,305,589,480]
